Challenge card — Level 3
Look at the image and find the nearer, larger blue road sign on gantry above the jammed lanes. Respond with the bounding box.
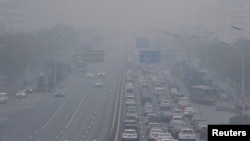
[139,50,160,63]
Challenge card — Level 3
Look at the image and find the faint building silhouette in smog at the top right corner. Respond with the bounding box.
[216,0,250,43]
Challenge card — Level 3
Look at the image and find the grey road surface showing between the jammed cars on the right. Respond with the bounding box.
[119,64,245,141]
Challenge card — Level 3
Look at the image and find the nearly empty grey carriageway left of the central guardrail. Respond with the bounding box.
[0,38,123,141]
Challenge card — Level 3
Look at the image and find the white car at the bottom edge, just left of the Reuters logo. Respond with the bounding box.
[178,128,196,141]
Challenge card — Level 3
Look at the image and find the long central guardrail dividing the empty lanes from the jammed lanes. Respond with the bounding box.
[108,66,124,141]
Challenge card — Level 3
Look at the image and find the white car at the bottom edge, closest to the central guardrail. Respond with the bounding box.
[122,129,139,141]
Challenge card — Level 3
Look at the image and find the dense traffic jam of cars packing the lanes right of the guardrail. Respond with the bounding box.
[120,65,208,141]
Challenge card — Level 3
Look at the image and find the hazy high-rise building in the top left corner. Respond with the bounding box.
[0,0,25,33]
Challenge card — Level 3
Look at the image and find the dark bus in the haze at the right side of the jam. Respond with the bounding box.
[190,85,218,104]
